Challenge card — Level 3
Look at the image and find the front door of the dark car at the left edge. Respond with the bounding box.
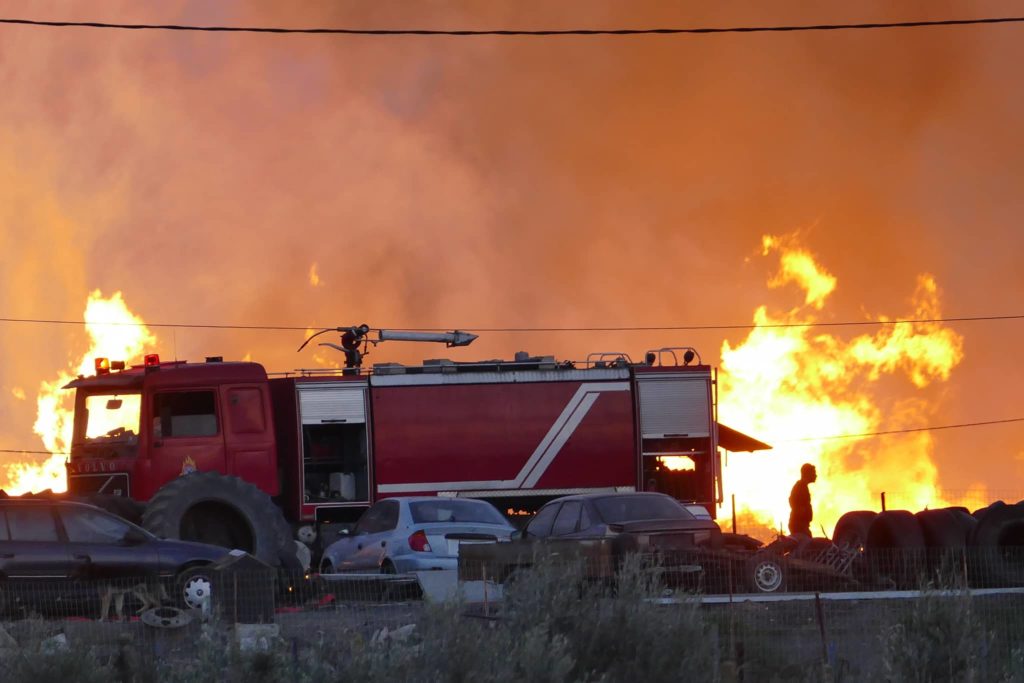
[57,505,160,581]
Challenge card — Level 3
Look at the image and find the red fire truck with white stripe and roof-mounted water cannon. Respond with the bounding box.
[67,326,768,561]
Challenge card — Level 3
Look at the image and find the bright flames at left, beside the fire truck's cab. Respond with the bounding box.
[4,290,157,495]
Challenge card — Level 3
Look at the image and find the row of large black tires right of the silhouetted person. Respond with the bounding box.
[833,501,1024,589]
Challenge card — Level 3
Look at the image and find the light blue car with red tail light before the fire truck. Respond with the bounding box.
[321,497,515,574]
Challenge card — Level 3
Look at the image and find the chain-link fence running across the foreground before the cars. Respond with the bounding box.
[0,544,1024,683]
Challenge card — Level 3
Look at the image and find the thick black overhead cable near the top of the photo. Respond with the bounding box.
[0,16,1024,37]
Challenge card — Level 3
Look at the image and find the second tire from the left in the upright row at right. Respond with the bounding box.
[864,510,926,589]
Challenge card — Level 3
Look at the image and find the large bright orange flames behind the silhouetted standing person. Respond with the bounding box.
[719,237,983,536]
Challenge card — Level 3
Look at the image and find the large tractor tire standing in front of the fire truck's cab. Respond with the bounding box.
[142,472,294,566]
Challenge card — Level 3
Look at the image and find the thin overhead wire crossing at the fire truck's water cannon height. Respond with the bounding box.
[0,313,1024,333]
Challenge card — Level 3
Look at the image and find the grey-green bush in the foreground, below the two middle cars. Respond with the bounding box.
[296,562,717,683]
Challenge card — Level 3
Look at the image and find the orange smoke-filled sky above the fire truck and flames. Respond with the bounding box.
[0,0,1024,496]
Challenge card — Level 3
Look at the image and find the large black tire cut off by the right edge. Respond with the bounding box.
[968,501,1024,586]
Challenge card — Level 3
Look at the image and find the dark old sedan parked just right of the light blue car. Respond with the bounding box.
[459,493,722,583]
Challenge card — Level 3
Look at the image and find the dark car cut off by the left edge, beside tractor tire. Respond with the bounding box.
[0,499,228,610]
